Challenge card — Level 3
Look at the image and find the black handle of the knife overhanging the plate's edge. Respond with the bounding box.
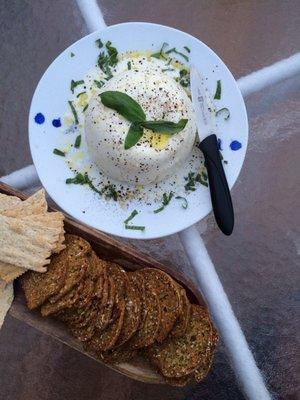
[200,134,234,235]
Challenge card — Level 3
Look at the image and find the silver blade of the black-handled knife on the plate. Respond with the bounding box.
[190,65,217,141]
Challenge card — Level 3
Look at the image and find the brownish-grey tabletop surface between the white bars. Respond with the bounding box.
[0,0,300,400]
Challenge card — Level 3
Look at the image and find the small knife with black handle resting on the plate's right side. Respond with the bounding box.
[190,66,234,235]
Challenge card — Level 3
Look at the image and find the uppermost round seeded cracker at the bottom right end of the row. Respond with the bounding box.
[147,304,211,378]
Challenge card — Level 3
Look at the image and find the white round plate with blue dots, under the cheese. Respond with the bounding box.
[29,22,248,239]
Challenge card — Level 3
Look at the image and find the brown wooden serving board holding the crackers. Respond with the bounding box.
[0,182,205,383]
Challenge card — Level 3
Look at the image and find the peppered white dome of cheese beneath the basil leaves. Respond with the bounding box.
[84,65,196,185]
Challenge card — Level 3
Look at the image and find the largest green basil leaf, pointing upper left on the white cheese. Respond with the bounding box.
[100,91,146,122]
